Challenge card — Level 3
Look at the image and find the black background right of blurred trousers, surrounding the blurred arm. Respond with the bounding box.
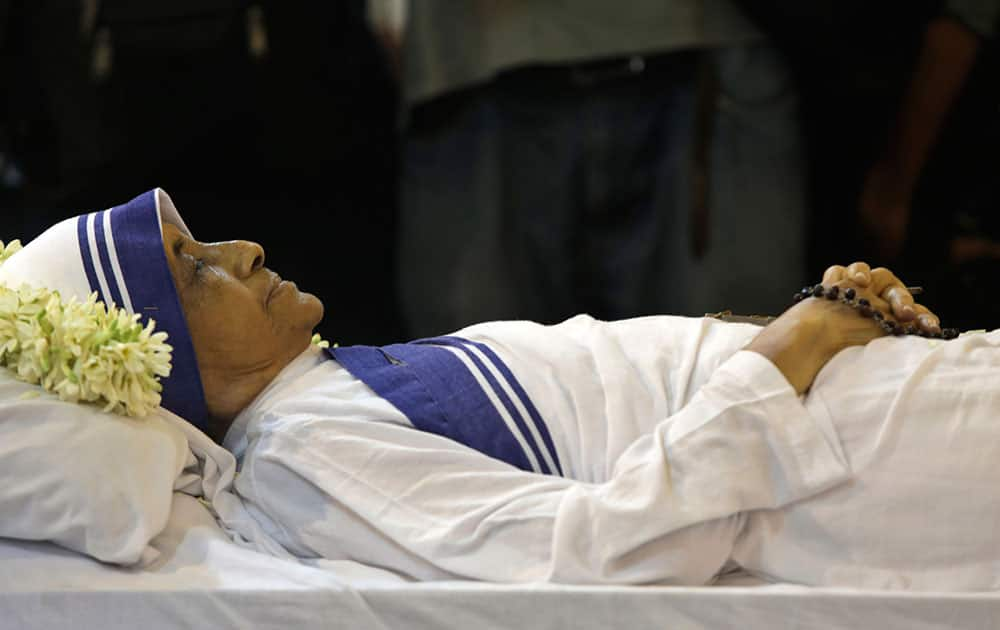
[738,0,1000,330]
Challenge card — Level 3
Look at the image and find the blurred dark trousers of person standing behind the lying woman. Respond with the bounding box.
[399,43,804,336]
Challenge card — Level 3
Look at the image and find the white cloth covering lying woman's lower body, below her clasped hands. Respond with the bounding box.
[733,330,1000,591]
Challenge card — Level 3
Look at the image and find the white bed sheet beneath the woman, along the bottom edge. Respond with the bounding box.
[0,494,1000,630]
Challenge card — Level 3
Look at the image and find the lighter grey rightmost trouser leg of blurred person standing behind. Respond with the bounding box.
[660,44,812,315]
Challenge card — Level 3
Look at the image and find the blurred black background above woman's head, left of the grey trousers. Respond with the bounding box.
[0,0,401,343]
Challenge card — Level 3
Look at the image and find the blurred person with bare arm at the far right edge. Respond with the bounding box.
[900,0,1000,330]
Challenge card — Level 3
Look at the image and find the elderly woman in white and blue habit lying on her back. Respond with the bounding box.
[0,190,1000,590]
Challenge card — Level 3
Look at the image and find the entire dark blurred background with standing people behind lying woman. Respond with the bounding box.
[0,0,1000,344]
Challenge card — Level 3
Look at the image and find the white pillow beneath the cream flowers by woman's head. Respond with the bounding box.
[0,368,192,564]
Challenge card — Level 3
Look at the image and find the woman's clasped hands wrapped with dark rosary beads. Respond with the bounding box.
[747,263,951,394]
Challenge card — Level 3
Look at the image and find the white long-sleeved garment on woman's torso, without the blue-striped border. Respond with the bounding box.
[225,316,848,584]
